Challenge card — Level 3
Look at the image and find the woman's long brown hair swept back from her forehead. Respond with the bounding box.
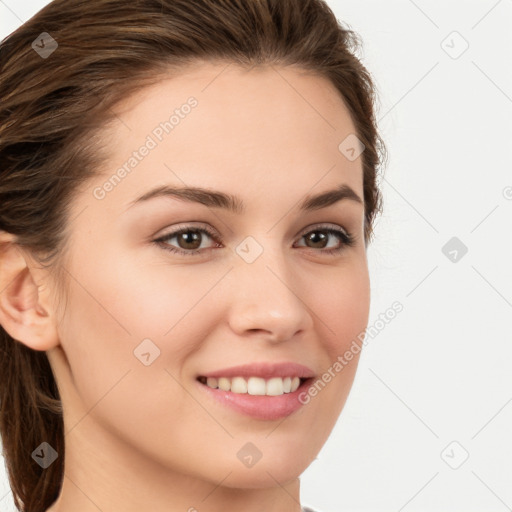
[0,0,386,512]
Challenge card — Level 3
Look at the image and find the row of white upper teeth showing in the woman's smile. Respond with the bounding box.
[202,377,300,396]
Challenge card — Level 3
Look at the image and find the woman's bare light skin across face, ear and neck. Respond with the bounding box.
[0,63,370,512]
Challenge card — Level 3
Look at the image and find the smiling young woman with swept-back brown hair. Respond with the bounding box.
[0,0,384,512]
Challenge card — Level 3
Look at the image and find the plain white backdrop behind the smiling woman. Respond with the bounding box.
[0,0,512,512]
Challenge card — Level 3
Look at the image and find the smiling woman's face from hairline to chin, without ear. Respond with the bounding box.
[48,63,370,487]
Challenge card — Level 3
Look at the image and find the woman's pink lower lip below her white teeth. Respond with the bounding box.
[197,379,312,420]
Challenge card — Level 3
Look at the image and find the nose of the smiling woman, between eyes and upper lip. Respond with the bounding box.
[228,243,313,343]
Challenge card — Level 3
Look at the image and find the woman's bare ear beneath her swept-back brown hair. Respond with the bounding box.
[0,231,59,351]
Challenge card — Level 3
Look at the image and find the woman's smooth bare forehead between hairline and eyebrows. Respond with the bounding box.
[87,63,362,214]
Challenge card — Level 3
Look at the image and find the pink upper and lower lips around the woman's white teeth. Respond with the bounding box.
[197,363,315,420]
